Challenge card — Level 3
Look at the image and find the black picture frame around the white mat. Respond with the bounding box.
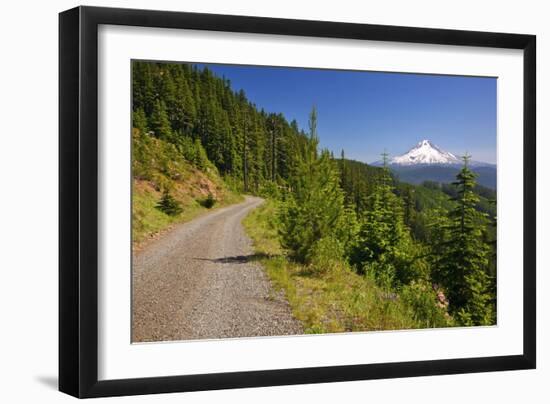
[59,7,536,398]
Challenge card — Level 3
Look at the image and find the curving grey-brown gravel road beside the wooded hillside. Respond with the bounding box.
[132,197,302,342]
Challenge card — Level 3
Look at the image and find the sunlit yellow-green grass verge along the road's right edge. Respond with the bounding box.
[244,201,452,334]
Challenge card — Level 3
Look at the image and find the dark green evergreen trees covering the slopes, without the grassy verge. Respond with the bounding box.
[132,61,496,327]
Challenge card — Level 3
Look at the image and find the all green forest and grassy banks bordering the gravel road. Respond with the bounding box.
[132,61,497,333]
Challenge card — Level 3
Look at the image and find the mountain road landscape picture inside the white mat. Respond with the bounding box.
[133,60,500,343]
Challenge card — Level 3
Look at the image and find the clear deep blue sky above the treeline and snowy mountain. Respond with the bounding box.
[196,64,497,163]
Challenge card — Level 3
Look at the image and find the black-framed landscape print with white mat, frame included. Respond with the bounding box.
[59,7,536,397]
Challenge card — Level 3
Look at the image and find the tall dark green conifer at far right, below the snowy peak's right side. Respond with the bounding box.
[434,156,493,325]
